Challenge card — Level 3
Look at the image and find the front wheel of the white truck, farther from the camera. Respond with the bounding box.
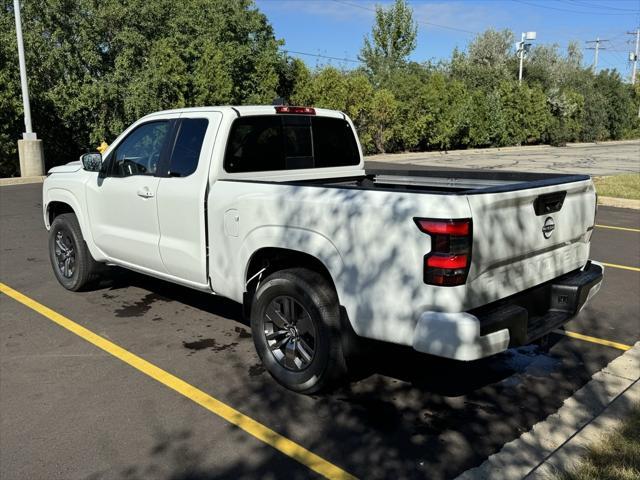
[49,213,101,292]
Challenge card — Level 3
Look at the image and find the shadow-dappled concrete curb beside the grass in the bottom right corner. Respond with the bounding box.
[456,342,640,480]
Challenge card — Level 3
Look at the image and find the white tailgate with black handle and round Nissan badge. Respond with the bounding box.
[466,179,596,305]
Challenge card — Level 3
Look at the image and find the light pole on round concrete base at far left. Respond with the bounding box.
[13,0,44,177]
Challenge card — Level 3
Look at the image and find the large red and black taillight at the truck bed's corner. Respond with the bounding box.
[414,218,472,287]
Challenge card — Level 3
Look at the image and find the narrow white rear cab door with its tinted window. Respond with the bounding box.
[157,112,222,285]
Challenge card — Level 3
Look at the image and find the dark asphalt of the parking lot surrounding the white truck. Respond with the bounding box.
[0,184,640,480]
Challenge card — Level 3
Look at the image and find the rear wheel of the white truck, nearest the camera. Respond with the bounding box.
[251,268,346,394]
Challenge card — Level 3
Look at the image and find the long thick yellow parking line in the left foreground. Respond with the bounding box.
[0,282,355,479]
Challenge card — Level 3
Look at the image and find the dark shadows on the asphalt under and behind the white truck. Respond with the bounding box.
[87,264,606,480]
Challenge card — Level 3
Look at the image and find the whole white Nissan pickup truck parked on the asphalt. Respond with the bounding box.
[42,106,603,393]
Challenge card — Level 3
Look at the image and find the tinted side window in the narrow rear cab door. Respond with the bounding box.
[169,118,209,177]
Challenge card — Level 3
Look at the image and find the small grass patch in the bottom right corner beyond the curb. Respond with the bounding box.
[556,404,640,480]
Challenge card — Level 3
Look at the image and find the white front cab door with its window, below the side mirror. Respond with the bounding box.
[87,115,177,273]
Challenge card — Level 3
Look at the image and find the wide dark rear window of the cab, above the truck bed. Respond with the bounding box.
[224,115,360,173]
